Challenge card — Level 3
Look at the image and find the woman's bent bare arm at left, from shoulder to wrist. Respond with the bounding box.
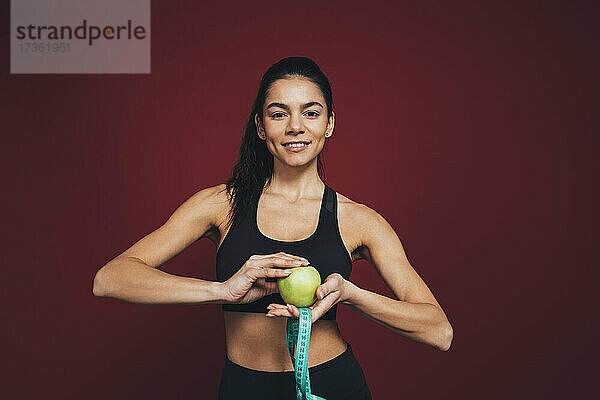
[93,184,227,304]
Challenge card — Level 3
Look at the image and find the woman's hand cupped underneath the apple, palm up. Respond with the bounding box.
[266,272,352,323]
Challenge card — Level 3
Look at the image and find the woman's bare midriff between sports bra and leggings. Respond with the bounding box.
[223,311,346,372]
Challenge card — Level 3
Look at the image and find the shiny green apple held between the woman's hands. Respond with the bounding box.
[277,265,321,307]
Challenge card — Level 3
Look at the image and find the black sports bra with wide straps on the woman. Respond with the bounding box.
[216,185,352,320]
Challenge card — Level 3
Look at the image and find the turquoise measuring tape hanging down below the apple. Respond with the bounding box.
[285,307,325,400]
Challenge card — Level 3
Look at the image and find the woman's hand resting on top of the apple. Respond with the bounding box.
[224,252,309,304]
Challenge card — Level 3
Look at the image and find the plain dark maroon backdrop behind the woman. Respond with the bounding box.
[0,1,599,400]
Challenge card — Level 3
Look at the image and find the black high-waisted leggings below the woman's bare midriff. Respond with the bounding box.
[219,342,371,400]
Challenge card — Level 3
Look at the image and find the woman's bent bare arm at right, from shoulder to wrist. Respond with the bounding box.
[342,204,453,351]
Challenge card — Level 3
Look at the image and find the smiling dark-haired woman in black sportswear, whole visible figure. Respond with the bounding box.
[94,57,452,400]
